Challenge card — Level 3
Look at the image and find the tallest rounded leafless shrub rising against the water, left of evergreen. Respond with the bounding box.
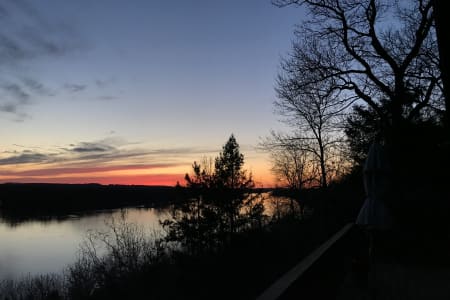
[65,218,168,298]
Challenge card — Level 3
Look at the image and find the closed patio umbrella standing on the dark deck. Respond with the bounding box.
[356,142,392,230]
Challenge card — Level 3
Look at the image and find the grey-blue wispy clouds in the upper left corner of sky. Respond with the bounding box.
[0,0,84,121]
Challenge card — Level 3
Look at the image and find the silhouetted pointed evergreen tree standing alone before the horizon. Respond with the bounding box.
[163,135,263,253]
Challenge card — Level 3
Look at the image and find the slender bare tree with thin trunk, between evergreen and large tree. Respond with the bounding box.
[275,77,348,187]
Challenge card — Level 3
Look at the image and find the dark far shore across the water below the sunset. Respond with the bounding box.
[0,183,180,216]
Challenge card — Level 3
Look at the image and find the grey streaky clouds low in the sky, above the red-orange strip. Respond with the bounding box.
[0,137,217,175]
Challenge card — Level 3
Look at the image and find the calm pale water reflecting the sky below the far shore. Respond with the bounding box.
[0,193,298,280]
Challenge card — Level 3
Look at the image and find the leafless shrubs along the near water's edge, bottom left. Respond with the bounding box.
[0,217,169,300]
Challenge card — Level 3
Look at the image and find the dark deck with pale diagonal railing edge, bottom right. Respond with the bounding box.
[258,227,450,300]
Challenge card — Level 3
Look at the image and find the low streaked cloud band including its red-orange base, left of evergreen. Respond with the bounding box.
[0,137,229,184]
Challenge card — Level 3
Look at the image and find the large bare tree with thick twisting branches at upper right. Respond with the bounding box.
[273,0,444,141]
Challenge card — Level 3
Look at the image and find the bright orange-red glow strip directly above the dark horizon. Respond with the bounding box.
[0,161,275,188]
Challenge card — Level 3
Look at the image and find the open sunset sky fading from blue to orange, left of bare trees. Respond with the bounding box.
[0,0,302,186]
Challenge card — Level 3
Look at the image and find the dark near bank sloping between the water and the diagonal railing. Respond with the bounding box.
[0,211,344,300]
